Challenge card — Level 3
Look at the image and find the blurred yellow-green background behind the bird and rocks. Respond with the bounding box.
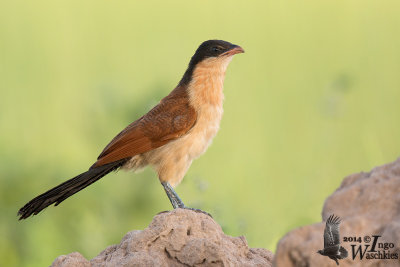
[0,0,400,266]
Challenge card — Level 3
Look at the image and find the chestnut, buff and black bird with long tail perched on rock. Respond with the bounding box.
[18,40,244,220]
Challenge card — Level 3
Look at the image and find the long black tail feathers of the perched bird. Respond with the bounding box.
[18,159,128,220]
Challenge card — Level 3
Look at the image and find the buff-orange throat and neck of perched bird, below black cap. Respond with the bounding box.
[187,57,231,111]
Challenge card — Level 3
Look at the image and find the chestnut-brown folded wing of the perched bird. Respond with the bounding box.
[93,92,197,166]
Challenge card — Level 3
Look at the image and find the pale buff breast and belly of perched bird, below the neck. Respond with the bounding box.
[145,106,222,186]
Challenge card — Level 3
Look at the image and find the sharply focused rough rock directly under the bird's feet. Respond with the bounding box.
[52,209,273,267]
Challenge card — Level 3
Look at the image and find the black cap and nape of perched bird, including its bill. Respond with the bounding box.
[180,40,244,84]
